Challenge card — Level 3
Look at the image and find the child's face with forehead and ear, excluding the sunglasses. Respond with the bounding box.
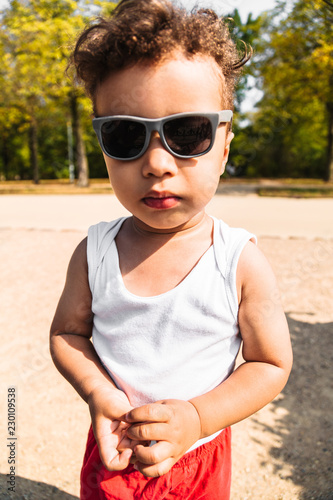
[95,54,233,231]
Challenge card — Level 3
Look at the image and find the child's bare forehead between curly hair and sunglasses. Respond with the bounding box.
[95,53,224,118]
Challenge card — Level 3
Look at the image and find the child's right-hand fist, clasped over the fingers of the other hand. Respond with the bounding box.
[126,399,201,477]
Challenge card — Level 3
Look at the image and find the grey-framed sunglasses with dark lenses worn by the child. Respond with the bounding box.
[93,110,233,160]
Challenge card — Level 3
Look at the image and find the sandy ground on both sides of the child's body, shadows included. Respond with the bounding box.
[0,196,333,500]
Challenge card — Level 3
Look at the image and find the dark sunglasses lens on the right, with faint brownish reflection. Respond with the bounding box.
[163,116,213,156]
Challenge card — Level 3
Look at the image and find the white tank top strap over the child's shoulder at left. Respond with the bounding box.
[87,217,127,292]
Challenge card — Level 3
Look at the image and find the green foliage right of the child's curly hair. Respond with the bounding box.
[230,0,333,178]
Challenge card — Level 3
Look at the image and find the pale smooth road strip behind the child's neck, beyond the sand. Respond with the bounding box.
[0,193,333,239]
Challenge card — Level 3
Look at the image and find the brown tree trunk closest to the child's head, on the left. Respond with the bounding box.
[71,92,89,187]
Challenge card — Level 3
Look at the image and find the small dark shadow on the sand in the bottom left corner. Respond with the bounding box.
[0,474,79,500]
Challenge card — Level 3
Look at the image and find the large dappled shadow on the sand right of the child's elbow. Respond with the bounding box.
[253,315,333,500]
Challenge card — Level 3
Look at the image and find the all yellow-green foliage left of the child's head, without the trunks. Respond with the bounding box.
[0,0,113,179]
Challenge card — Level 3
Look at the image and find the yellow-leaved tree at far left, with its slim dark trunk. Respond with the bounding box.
[0,0,74,183]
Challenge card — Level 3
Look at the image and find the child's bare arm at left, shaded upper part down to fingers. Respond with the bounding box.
[50,240,136,470]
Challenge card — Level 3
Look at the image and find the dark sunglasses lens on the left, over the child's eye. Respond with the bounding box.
[101,120,146,160]
